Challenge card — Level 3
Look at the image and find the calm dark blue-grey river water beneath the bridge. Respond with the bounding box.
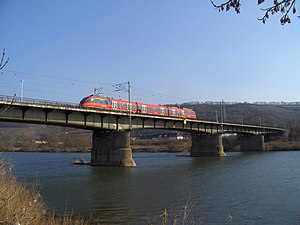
[0,151,300,225]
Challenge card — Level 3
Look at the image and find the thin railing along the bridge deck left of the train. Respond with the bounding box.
[0,95,79,108]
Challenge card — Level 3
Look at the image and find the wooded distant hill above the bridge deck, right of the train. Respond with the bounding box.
[181,103,300,128]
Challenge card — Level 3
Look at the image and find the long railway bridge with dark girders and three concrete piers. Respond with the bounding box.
[0,96,285,166]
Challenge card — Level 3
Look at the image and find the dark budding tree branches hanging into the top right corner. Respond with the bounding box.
[211,0,300,25]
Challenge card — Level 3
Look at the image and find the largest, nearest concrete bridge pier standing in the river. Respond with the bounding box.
[91,131,136,167]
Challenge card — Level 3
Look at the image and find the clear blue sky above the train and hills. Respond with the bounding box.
[0,0,300,104]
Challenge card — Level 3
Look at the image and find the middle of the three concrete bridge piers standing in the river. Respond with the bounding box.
[191,134,226,156]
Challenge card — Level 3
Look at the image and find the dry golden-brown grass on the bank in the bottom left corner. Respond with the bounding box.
[0,159,87,225]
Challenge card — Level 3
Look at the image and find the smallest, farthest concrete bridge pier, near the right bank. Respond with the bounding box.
[239,135,265,152]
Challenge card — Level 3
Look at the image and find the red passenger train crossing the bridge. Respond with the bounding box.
[79,95,196,119]
